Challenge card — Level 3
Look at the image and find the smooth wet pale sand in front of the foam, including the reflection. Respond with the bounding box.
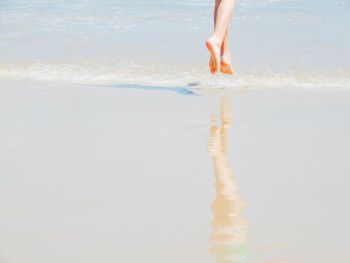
[0,81,350,263]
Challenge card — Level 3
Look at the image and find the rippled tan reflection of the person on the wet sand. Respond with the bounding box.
[208,97,248,263]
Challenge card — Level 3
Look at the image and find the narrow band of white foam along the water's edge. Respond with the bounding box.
[0,61,350,89]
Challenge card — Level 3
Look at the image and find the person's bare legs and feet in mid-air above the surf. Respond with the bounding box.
[206,0,236,74]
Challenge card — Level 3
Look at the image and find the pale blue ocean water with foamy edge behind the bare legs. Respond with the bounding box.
[0,0,350,88]
